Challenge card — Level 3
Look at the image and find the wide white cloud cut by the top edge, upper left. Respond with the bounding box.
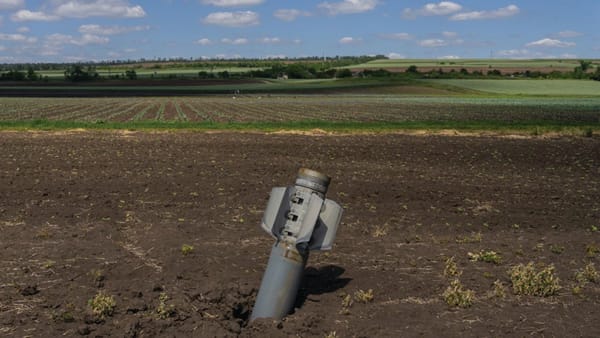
[54,0,146,18]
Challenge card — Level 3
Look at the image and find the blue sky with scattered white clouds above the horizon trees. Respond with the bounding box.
[0,0,600,63]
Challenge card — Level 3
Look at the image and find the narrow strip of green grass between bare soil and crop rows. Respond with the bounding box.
[0,120,600,137]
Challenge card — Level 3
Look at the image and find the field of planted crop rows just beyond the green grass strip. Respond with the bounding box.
[0,95,600,123]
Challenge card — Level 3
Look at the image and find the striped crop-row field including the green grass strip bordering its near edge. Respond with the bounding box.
[0,94,600,135]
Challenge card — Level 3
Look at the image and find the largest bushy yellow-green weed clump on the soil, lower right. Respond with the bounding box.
[508,262,560,297]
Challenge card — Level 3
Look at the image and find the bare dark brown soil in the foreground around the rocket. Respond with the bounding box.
[0,132,600,337]
